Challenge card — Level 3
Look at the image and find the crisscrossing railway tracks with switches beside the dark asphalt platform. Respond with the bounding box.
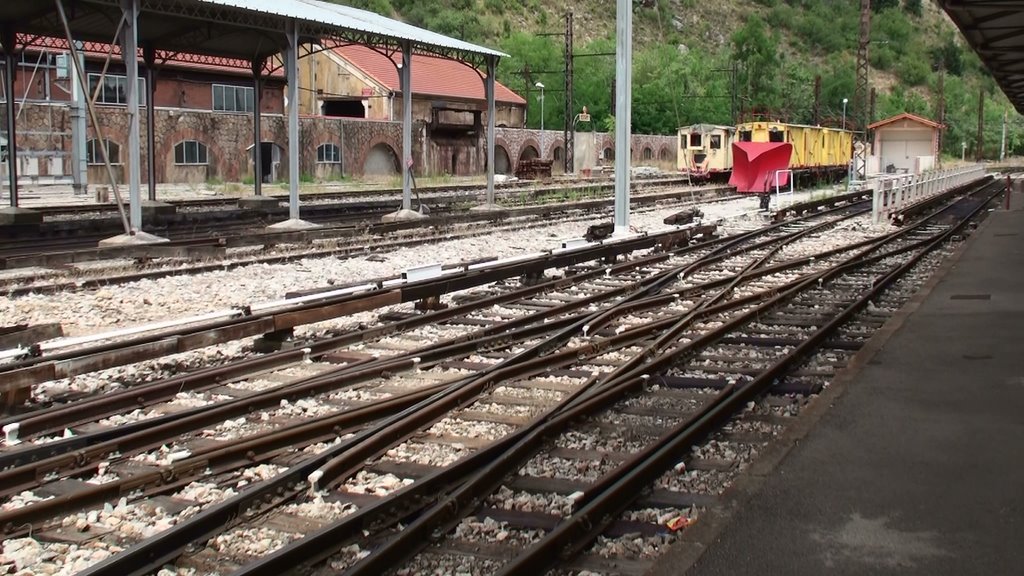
[0,177,991,574]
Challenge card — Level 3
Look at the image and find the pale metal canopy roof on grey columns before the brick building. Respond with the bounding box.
[0,0,505,66]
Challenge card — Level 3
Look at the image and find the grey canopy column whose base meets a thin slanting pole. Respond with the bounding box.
[121,0,142,233]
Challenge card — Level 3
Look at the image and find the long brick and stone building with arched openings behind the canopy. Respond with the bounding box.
[6,40,675,184]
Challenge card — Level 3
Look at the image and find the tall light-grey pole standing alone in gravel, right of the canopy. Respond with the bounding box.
[614,0,633,236]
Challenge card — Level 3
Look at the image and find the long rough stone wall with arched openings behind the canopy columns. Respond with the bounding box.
[8,102,676,182]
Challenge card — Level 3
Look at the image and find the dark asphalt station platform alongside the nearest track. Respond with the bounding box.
[652,192,1024,576]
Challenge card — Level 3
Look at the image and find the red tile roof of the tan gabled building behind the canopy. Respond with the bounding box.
[335,44,526,105]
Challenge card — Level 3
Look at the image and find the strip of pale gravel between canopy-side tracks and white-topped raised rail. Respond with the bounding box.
[0,191,831,336]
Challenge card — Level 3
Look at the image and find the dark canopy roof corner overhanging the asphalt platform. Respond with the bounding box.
[939,0,1024,114]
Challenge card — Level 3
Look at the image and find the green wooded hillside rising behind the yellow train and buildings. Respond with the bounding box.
[338,0,1024,158]
